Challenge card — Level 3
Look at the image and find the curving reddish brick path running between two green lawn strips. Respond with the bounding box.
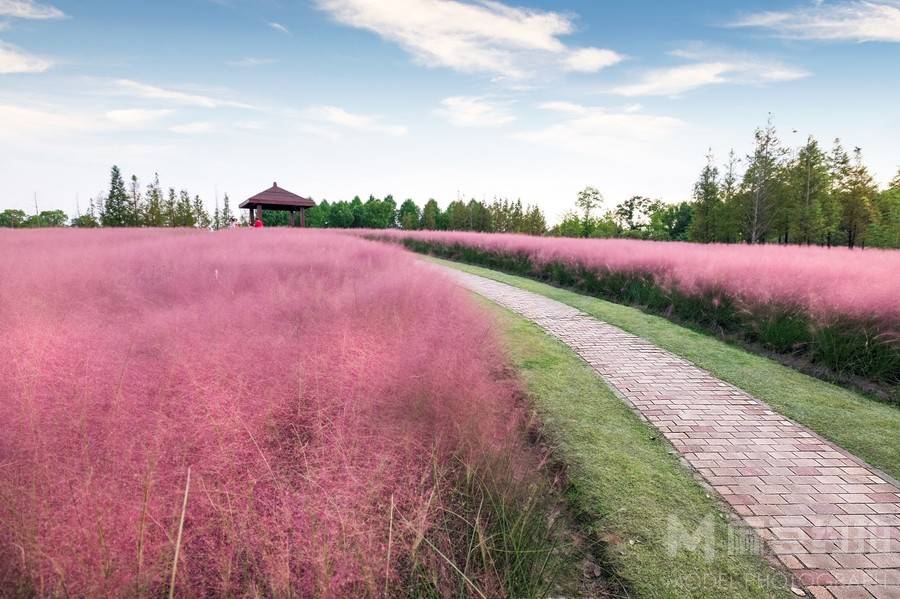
[438,267,900,599]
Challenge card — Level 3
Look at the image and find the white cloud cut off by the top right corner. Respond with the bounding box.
[730,0,900,42]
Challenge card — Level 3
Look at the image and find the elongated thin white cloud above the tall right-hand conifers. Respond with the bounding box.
[613,52,809,96]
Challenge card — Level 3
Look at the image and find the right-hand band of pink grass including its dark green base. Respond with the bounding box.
[364,231,900,397]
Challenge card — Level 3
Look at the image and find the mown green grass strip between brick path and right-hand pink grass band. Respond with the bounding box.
[433,259,900,478]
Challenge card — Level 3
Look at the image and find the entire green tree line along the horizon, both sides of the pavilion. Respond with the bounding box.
[0,121,900,248]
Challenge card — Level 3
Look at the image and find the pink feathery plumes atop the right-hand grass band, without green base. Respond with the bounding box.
[365,231,900,330]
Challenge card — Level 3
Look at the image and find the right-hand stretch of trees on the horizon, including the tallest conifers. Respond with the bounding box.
[550,121,900,248]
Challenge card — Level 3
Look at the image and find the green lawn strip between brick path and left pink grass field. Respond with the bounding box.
[485,301,791,599]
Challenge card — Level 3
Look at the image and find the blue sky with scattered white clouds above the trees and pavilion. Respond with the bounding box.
[0,0,900,222]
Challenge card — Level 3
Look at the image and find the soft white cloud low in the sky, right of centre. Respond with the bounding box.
[515,102,684,153]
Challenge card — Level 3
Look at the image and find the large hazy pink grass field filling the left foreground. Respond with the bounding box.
[0,229,524,597]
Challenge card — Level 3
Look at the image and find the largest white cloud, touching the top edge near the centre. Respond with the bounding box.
[316,0,618,79]
